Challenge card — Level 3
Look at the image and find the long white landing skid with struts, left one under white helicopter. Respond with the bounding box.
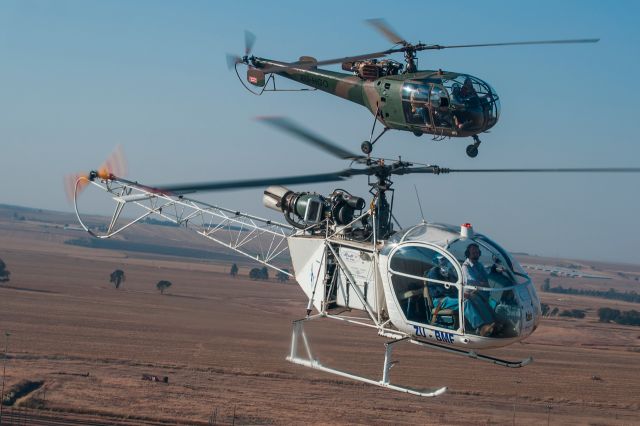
[287,319,447,397]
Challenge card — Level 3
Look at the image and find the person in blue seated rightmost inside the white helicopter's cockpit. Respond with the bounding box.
[462,243,496,337]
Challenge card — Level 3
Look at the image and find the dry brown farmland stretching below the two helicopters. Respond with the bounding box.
[0,208,640,425]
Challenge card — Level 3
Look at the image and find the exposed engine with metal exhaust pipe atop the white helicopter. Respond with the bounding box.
[262,186,368,237]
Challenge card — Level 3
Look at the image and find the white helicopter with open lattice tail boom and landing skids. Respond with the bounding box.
[70,118,640,396]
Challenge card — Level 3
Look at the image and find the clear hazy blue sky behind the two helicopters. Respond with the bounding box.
[0,0,640,264]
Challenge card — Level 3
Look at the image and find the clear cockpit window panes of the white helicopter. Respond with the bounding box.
[389,243,533,338]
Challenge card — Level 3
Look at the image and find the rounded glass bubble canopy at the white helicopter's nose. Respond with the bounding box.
[381,223,541,339]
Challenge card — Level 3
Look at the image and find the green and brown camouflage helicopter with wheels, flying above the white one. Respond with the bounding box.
[227,19,599,158]
